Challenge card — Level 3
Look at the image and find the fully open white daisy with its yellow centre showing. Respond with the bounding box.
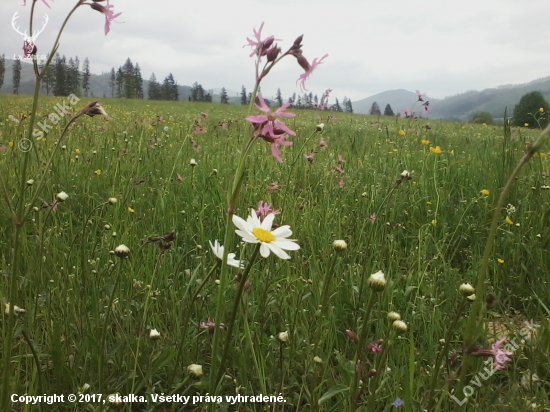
[233,209,300,259]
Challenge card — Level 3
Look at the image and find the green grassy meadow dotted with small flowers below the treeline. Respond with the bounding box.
[0,95,550,411]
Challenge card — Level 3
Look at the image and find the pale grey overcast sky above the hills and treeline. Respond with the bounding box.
[0,0,550,100]
